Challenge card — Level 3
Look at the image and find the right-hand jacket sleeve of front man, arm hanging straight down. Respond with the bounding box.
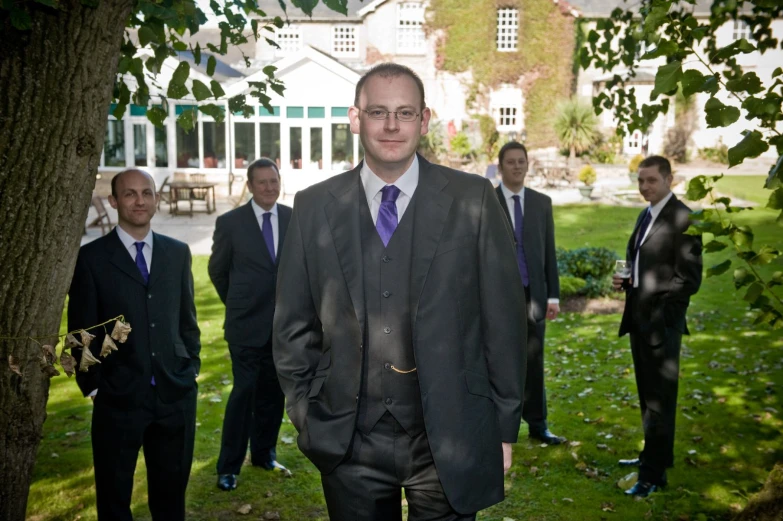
[478,181,527,443]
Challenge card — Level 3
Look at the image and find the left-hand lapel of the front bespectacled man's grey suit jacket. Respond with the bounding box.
[324,169,367,331]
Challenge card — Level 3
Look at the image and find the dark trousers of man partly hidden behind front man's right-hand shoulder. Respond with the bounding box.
[522,288,547,433]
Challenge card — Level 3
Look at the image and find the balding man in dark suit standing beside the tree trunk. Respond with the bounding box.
[68,169,201,521]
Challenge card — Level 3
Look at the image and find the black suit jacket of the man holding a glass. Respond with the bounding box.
[620,195,702,346]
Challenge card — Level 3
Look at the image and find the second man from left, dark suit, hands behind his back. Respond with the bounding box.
[209,158,291,490]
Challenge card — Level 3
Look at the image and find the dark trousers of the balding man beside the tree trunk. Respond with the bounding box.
[92,385,198,521]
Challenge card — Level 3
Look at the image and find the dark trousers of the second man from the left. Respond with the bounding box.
[217,339,285,474]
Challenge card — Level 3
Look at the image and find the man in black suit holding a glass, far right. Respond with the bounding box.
[613,156,702,497]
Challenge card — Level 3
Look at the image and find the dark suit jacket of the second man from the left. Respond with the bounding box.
[209,203,291,347]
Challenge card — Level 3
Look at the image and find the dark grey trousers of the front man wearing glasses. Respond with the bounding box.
[321,413,476,521]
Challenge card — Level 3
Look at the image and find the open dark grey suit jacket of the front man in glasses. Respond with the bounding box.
[274,157,527,512]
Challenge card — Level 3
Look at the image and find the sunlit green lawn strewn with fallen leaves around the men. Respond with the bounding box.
[28,197,783,521]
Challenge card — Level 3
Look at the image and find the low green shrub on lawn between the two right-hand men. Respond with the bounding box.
[557,248,618,298]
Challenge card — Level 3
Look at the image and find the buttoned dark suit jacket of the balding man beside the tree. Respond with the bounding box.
[68,230,201,408]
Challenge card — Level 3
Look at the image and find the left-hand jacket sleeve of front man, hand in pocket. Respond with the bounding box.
[272,196,323,431]
